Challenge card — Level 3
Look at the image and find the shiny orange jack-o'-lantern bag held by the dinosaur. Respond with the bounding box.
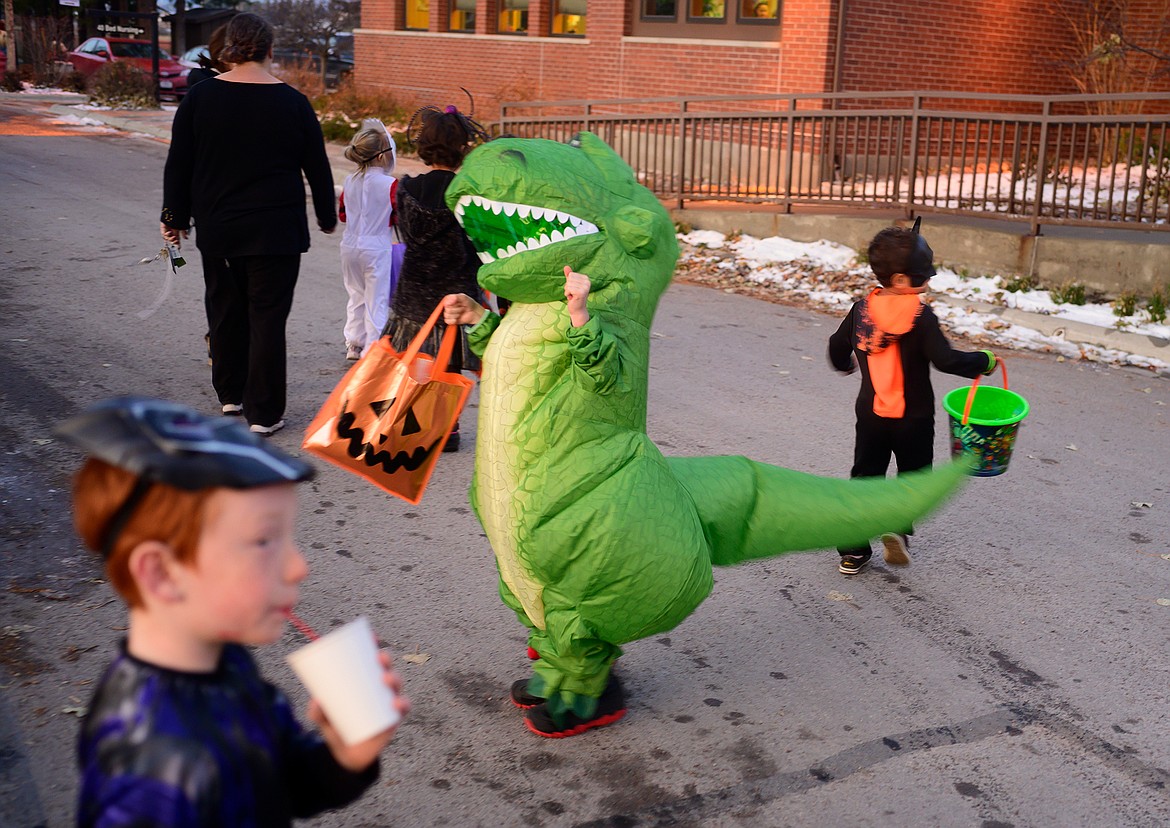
[303,304,475,503]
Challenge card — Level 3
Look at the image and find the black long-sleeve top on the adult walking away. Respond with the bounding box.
[161,78,337,256]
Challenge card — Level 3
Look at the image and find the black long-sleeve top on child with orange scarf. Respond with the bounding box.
[828,299,991,420]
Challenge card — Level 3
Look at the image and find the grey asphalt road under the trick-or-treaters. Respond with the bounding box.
[0,101,1170,828]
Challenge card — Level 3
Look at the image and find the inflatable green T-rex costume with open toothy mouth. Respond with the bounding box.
[447,132,965,718]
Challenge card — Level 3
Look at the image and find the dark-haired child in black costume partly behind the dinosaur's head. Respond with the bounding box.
[383,106,488,451]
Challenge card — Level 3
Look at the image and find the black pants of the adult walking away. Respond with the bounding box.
[202,254,301,426]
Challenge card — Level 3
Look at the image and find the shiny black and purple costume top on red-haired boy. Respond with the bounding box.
[77,643,378,828]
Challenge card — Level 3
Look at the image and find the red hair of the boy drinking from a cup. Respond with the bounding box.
[74,457,215,607]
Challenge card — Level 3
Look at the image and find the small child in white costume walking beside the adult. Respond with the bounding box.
[338,118,398,359]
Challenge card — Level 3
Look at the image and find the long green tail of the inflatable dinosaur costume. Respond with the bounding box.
[667,457,969,566]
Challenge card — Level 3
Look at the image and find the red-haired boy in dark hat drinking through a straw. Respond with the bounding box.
[57,398,410,827]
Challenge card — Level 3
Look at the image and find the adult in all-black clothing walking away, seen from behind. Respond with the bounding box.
[161,14,337,435]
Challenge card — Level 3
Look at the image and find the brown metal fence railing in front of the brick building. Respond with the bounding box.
[498,92,1170,235]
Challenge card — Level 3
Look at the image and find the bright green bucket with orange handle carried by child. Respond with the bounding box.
[943,360,1028,477]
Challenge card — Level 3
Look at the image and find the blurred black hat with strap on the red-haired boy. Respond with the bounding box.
[53,396,314,556]
